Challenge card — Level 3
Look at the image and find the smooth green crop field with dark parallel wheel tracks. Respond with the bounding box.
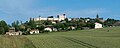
[26,27,120,48]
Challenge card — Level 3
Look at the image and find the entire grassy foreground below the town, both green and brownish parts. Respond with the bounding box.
[0,27,120,48]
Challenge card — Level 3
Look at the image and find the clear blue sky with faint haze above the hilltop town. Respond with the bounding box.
[0,0,120,24]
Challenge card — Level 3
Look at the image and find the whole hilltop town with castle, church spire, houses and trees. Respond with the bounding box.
[0,14,120,35]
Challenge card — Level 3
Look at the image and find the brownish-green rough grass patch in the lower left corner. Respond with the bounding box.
[0,35,36,48]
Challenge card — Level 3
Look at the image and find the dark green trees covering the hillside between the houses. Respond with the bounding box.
[0,16,119,34]
